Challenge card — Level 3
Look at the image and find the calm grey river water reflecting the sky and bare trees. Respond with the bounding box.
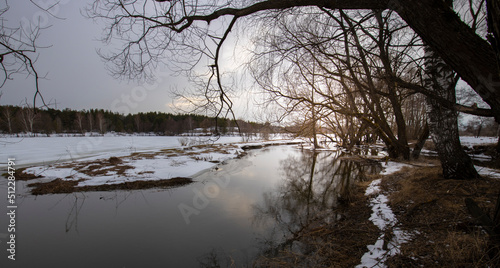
[0,146,376,267]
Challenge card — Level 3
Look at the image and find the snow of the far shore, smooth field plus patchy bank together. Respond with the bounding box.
[0,136,300,186]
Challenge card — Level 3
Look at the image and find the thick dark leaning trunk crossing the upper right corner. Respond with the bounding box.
[389,0,500,122]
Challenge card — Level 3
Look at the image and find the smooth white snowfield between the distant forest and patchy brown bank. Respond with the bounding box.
[0,134,242,166]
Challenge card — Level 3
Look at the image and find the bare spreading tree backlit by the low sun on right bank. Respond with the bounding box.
[250,9,428,159]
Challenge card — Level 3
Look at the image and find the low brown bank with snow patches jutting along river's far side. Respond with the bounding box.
[11,139,302,195]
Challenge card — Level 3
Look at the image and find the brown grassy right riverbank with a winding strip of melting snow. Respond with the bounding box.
[257,156,500,267]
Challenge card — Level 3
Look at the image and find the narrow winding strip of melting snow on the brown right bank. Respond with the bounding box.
[356,178,411,267]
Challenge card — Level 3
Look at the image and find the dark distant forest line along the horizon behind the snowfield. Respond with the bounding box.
[0,105,280,135]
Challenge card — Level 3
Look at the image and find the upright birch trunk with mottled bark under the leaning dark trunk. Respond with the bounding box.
[425,47,479,179]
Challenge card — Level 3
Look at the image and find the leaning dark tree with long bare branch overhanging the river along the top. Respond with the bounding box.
[88,0,500,121]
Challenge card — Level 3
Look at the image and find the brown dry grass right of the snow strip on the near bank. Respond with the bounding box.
[382,164,500,267]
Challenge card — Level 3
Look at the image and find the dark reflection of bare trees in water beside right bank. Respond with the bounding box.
[256,151,375,262]
